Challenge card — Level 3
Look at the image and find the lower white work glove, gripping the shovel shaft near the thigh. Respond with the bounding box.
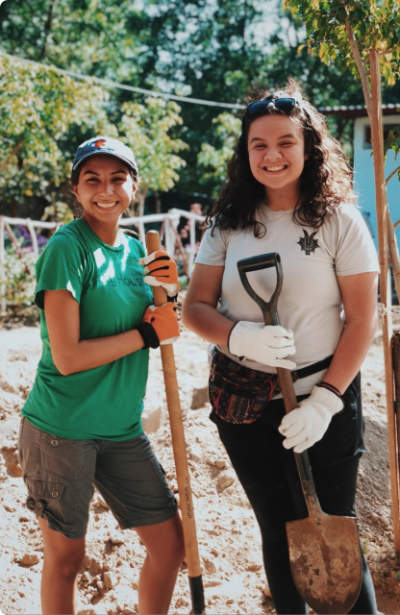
[279,386,344,453]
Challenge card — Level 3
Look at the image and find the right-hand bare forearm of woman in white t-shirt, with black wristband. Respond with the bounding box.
[318,272,378,393]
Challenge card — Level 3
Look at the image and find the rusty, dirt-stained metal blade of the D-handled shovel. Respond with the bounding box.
[286,511,362,615]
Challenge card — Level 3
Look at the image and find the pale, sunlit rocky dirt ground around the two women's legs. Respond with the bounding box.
[0,312,400,615]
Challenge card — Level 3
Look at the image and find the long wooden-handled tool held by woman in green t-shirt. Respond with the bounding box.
[146,230,205,615]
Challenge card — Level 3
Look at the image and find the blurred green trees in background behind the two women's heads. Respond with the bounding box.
[0,0,400,219]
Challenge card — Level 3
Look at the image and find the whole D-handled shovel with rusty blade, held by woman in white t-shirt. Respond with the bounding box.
[237,252,362,615]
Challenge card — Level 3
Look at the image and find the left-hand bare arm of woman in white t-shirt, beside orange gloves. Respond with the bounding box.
[182,264,234,345]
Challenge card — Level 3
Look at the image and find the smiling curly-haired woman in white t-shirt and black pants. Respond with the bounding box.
[183,83,378,614]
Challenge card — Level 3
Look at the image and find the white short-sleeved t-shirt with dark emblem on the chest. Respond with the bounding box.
[196,205,379,395]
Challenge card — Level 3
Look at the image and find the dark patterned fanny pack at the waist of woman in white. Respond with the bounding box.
[209,349,279,424]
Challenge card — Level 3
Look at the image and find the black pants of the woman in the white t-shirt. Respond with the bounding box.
[210,376,377,615]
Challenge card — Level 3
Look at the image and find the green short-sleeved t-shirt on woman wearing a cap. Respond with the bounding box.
[22,220,152,440]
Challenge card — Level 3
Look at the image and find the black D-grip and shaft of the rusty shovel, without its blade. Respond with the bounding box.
[237,252,321,517]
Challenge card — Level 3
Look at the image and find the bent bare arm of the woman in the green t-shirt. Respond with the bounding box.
[44,290,144,376]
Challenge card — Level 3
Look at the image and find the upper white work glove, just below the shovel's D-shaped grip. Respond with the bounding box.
[228,320,296,369]
